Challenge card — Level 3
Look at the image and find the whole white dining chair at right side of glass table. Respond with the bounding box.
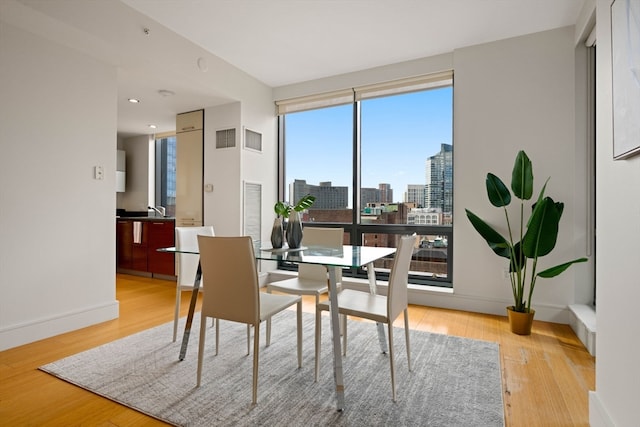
[316,234,417,402]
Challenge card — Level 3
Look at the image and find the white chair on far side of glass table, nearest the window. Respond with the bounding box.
[267,227,344,381]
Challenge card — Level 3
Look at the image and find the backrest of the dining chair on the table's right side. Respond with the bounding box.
[387,234,418,321]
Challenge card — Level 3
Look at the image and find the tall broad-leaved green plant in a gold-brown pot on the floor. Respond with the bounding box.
[465,151,587,335]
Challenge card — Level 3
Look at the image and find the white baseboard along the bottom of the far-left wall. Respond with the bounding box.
[0,300,120,351]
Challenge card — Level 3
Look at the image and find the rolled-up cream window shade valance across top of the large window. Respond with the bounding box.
[276,71,453,115]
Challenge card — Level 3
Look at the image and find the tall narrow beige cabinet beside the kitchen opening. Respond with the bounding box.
[175,110,204,226]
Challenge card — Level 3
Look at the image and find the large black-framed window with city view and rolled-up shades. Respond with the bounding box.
[279,73,453,286]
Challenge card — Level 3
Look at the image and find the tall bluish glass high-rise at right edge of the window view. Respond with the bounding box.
[424,144,453,213]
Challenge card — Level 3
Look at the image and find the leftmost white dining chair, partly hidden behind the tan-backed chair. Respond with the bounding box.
[173,225,215,342]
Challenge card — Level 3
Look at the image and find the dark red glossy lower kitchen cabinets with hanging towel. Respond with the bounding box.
[116,218,175,276]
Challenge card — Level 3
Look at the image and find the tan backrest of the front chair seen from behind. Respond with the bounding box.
[198,236,260,325]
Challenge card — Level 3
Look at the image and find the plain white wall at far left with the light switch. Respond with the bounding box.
[0,22,118,350]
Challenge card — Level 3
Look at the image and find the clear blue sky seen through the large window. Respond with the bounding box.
[285,87,453,205]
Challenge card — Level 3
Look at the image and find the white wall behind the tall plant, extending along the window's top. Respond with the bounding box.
[274,27,590,323]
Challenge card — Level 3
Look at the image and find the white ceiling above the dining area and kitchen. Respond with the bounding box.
[7,0,586,137]
